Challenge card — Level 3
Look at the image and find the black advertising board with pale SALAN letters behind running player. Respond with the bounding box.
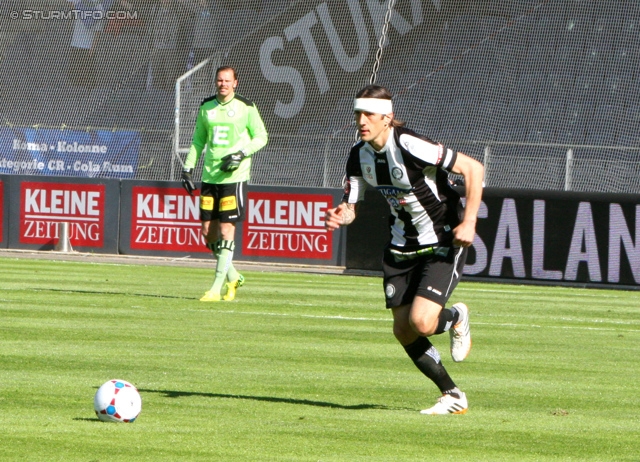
[347,189,640,287]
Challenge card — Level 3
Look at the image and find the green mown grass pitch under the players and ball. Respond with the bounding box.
[0,258,640,462]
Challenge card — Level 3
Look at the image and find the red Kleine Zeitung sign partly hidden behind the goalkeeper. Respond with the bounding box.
[130,186,209,253]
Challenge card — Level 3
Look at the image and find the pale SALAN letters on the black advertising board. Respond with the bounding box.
[465,198,640,283]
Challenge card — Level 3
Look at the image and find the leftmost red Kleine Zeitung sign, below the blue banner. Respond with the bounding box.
[19,181,105,247]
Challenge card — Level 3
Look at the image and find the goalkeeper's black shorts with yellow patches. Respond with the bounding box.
[200,182,246,223]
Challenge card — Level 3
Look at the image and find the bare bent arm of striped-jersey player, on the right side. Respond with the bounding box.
[451,152,484,247]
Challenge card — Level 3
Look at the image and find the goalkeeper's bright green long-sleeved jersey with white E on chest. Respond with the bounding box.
[184,93,268,184]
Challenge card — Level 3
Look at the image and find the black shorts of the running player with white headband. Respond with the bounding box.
[382,247,468,308]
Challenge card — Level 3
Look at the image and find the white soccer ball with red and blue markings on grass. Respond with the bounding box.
[93,379,142,422]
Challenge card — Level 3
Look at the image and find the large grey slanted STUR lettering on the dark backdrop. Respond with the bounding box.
[259,0,441,119]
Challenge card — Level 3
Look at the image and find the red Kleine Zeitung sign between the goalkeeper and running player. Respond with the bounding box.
[242,192,333,260]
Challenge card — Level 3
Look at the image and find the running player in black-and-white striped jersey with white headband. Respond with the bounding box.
[325,85,484,414]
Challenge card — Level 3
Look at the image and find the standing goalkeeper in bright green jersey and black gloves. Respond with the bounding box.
[182,66,267,302]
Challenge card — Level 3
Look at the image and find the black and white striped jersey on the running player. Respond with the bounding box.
[343,127,461,252]
